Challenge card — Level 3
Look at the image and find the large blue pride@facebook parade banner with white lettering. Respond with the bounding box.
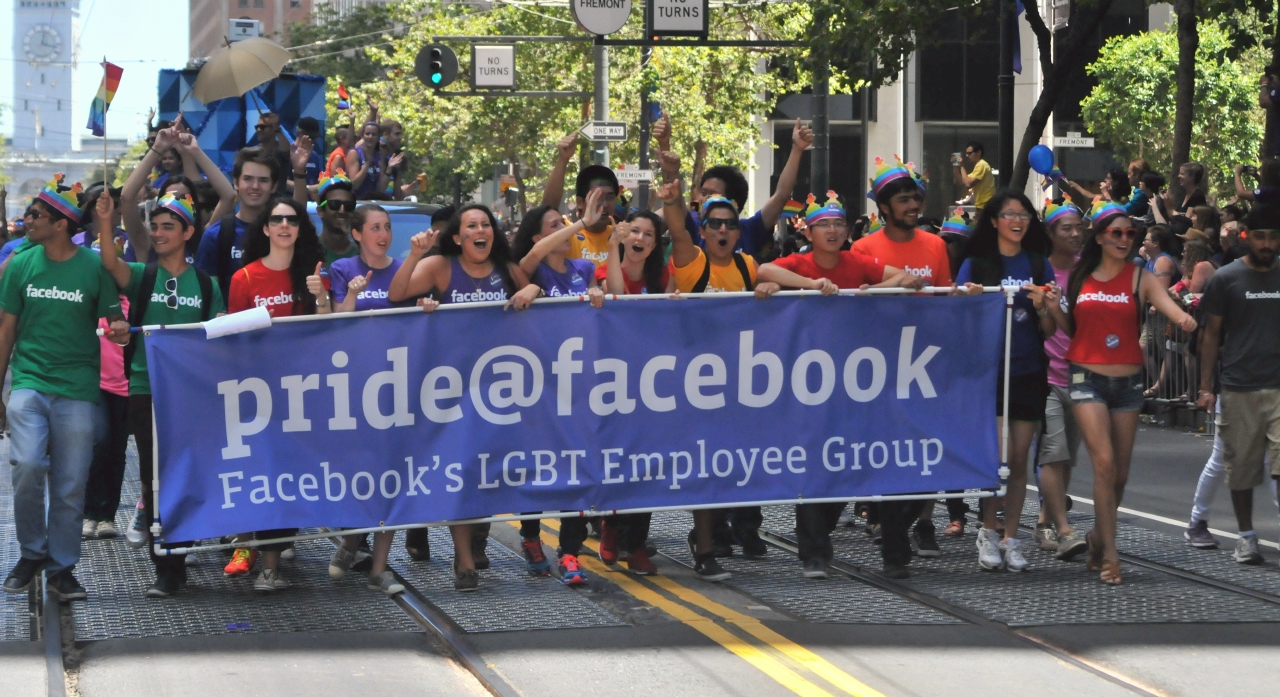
[146,294,1005,541]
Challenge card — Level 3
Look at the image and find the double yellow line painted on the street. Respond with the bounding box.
[511,519,884,697]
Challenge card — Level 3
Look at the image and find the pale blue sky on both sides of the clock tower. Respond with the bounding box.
[0,0,188,138]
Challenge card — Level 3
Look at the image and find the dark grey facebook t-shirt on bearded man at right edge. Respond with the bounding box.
[1201,260,1280,391]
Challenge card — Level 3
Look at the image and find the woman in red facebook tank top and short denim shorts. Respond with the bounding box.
[1066,200,1196,586]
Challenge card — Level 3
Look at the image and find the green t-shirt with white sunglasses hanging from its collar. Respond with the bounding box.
[124,262,227,395]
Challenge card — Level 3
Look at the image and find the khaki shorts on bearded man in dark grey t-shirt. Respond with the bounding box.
[1217,389,1280,491]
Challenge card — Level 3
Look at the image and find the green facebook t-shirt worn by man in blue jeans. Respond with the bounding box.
[0,247,120,404]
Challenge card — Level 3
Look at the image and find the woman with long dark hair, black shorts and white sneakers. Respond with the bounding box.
[956,190,1059,572]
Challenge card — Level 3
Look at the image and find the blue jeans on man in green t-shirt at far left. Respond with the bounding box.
[9,389,96,574]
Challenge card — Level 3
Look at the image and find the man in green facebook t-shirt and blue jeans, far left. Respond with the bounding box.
[0,174,128,600]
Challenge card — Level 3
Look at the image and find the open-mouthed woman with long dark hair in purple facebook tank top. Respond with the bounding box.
[388,203,543,591]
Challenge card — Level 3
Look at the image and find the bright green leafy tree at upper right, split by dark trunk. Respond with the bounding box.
[1080,20,1270,197]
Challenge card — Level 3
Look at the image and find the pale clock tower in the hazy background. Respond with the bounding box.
[13,0,88,153]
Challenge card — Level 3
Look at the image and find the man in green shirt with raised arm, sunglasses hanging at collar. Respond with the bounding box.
[96,194,227,597]
